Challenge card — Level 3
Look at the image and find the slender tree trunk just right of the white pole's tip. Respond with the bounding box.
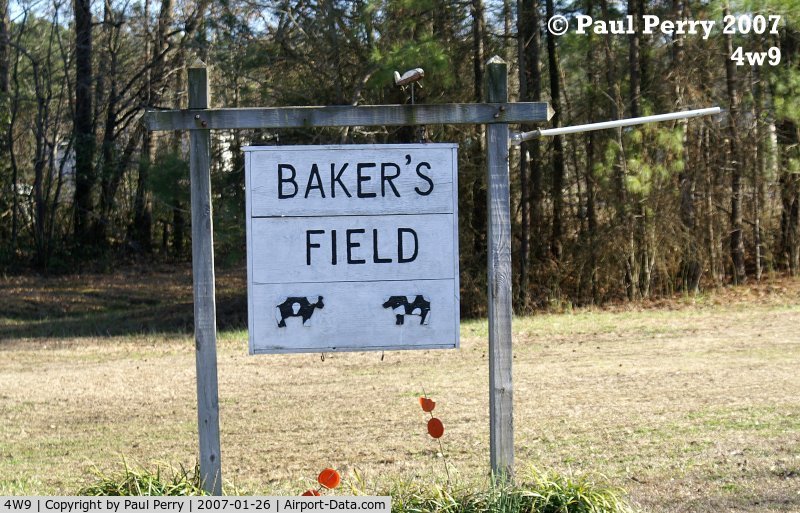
[723,4,747,284]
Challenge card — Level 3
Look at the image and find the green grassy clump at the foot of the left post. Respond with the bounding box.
[77,460,206,496]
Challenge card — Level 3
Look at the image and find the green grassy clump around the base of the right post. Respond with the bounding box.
[390,471,635,513]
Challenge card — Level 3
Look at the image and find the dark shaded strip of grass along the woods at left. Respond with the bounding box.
[0,265,247,341]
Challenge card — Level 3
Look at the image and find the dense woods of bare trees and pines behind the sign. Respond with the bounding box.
[0,0,800,316]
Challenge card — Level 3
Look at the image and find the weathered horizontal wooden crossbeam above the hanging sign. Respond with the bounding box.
[145,102,553,131]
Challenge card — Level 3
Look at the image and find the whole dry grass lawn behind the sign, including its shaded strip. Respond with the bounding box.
[0,268,800,512]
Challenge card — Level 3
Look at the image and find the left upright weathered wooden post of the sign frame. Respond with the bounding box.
[189,67,222,495]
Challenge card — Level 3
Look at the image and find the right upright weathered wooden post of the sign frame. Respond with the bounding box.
[486,57,514,479]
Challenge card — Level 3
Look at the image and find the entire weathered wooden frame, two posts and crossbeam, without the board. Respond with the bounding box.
[145,57,553,495]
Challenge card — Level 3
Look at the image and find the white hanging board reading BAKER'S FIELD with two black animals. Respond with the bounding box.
[244,144,459,354]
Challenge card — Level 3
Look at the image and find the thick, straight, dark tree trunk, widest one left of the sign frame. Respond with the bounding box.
[74,0,96,244]
